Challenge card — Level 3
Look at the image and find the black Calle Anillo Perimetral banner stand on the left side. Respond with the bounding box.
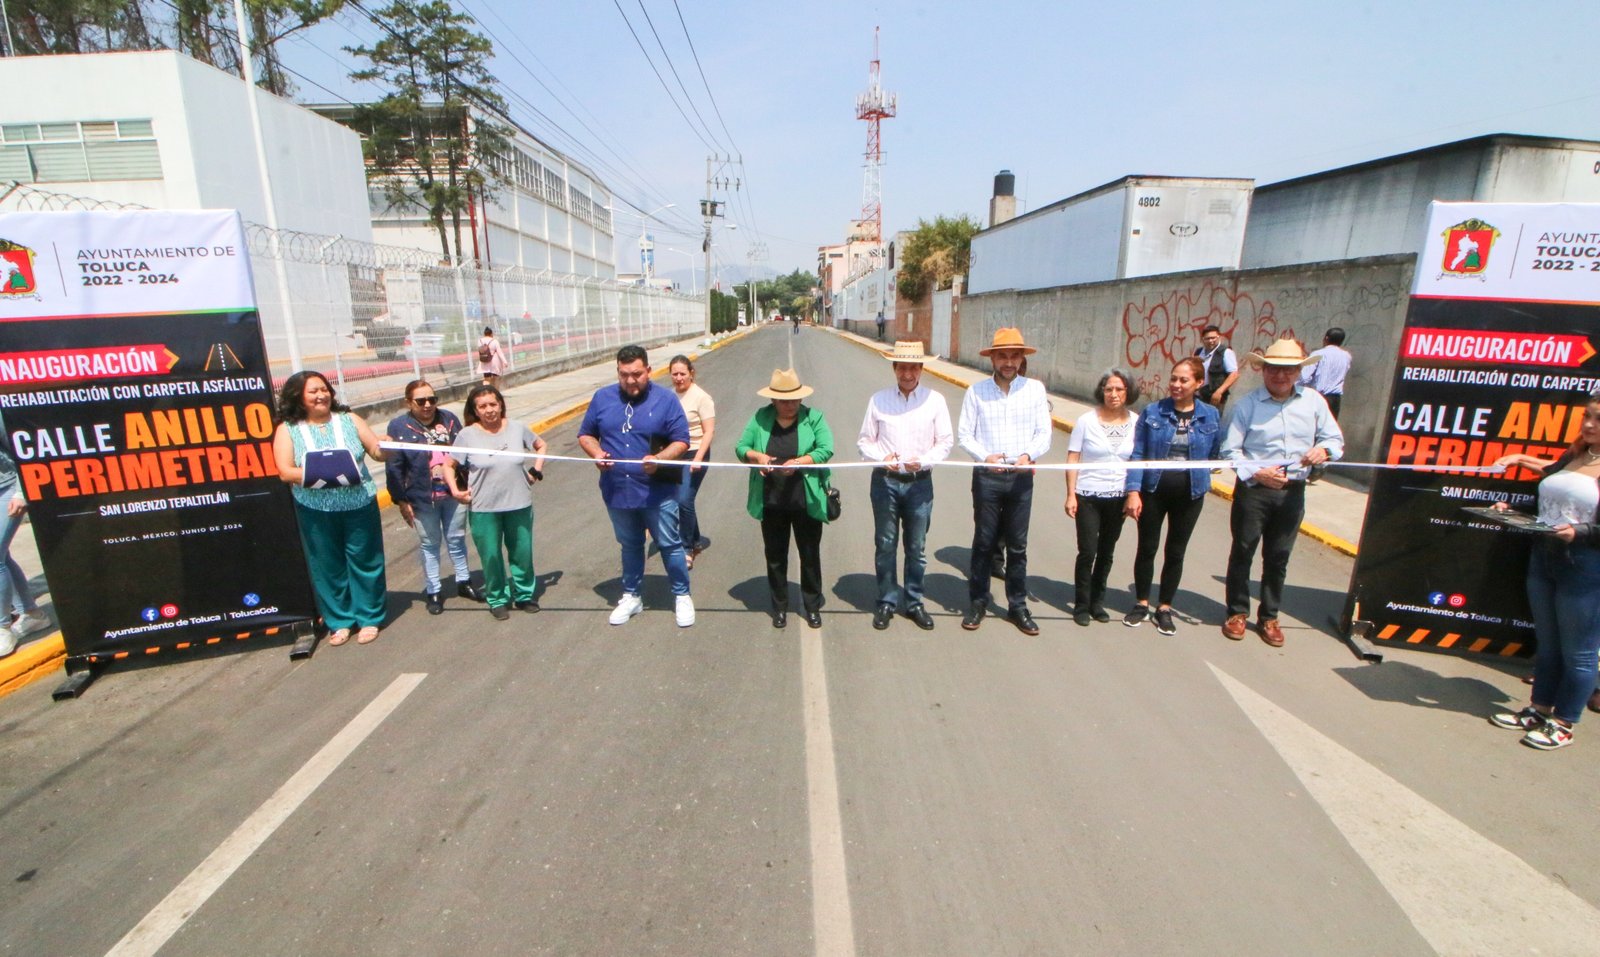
[0,210,317,701]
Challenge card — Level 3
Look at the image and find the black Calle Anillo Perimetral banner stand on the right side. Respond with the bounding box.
[1341,202,1600,661]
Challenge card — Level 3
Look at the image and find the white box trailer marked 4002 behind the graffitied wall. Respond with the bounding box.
[966,176,1254,294]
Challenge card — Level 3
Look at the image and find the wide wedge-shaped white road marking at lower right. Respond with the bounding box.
[1211,666,1600,957]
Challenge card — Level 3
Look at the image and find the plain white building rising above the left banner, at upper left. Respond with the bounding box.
[0,50,373,242]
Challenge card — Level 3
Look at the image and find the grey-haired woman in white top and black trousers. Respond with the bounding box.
[1066,368,1139,626]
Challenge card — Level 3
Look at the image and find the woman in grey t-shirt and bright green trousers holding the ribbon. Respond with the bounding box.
[454,386,544,621]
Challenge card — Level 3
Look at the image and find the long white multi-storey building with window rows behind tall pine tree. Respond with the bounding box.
[310,104,616,278]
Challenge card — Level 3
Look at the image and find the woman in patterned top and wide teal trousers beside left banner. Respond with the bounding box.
[272,371,389,645]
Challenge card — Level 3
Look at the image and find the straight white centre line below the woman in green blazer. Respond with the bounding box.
[800,623,856,957]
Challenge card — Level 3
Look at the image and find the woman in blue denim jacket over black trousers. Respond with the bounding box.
[1122,357,1222,635]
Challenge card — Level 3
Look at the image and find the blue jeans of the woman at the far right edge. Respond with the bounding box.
[1528,543,1600,725]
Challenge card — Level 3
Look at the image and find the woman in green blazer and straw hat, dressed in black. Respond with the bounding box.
[734,370,834,627]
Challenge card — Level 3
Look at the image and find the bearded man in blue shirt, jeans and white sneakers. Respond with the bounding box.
[578,346,694,627]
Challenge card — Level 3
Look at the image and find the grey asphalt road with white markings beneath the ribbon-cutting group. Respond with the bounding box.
[0,328,1600,957]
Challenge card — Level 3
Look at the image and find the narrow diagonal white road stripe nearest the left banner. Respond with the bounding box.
[106,674,427,957]
